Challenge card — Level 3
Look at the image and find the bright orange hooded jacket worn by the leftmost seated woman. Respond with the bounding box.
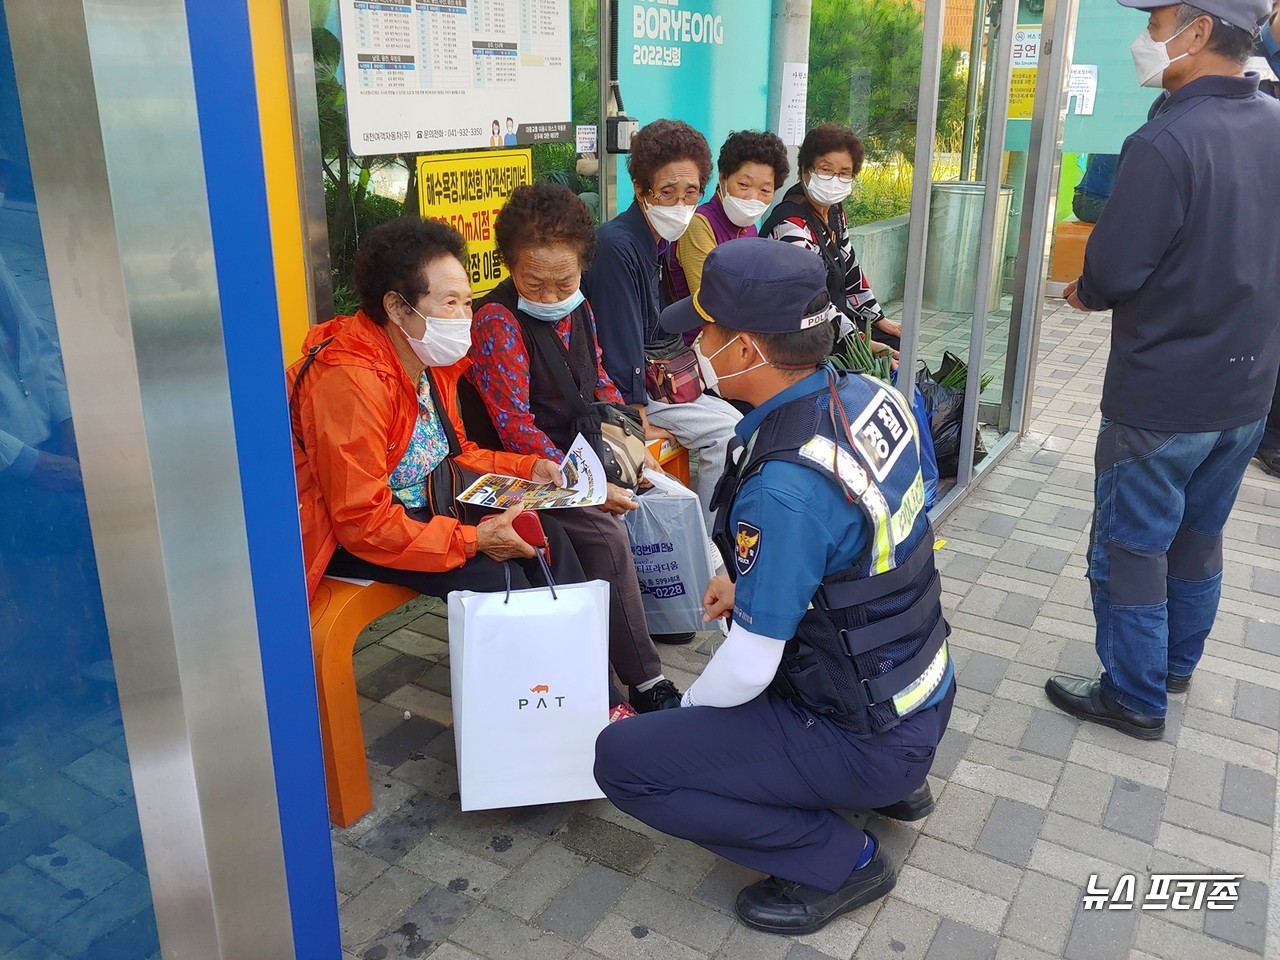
[287,311,538,595]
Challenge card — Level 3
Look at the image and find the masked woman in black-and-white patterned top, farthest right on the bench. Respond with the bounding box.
[760,123,902,349]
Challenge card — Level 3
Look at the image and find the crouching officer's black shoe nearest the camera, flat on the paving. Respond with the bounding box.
[733,839,897,936]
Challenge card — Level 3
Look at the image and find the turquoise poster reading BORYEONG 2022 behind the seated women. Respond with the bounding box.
[617,0,777,211]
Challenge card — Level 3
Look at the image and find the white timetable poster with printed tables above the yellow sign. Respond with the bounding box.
[338,0,573,156]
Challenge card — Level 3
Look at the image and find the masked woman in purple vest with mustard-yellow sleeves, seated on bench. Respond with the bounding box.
[671,131,791,308]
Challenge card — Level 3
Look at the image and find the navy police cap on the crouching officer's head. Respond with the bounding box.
[659,237,835,333]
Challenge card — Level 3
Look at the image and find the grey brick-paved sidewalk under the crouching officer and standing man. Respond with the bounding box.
[334,308,1280,960]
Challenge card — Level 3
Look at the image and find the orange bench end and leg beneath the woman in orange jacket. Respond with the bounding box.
[311,577,417,827]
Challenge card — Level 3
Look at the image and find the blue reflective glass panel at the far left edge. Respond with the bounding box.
[0,13,160,960]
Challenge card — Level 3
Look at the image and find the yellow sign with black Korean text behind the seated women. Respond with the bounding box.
[417,150,534,297]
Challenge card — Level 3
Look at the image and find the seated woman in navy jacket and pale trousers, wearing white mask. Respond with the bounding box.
[586,120,741,530]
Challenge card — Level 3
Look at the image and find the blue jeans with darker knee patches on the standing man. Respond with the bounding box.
[1089,417,1265,717]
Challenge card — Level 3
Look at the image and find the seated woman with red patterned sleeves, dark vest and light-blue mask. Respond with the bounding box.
[468,183,680,713]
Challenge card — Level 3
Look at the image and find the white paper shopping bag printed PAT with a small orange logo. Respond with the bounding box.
[449,580,609,810]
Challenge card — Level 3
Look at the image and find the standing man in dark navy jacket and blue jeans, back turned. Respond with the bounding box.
[1046,0,1280,740]
